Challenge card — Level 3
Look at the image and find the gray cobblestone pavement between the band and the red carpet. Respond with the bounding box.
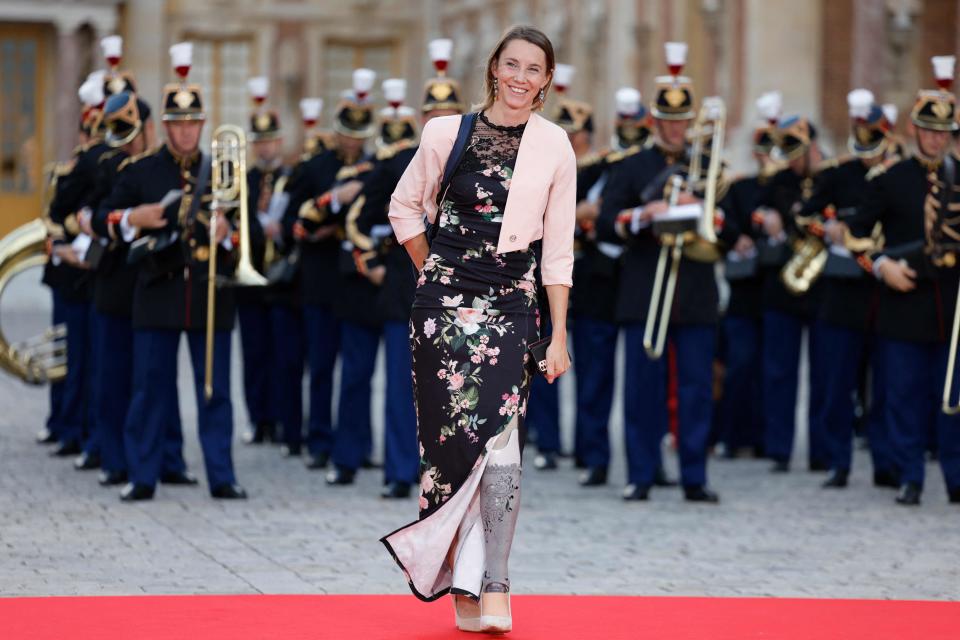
[0,280,960,599]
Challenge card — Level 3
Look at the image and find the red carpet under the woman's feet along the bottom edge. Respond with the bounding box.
[0,596,960,640]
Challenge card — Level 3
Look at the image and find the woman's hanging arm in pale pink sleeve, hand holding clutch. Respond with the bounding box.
[541,136,577,383]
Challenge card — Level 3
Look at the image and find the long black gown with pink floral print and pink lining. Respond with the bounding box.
[383,113,539,600]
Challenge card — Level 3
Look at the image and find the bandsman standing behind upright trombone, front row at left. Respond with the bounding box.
[101,43,246,501]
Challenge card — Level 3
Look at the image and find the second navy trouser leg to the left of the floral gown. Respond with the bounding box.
[331,321,381,470]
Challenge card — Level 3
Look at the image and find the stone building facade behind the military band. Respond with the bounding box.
[0,0,960,233]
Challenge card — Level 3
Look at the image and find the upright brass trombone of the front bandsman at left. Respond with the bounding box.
[207,124,267,401]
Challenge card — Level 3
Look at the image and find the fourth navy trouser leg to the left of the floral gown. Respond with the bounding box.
[267,305,305,448]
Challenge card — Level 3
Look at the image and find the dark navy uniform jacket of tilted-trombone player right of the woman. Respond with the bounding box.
[597,146,736,325]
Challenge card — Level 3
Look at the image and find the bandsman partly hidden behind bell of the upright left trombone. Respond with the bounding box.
[236,76,284,446]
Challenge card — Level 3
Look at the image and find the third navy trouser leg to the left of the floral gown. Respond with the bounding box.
[303,304,340,456]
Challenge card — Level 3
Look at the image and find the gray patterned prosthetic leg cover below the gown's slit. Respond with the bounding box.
[480,426,520,593]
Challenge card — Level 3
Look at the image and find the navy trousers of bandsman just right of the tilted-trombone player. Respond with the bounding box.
[717,315,763,450]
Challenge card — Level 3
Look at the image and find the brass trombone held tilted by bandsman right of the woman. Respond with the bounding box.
[643,98,726,360]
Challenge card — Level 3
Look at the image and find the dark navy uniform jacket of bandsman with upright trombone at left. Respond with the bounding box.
[100,145,236,330]
